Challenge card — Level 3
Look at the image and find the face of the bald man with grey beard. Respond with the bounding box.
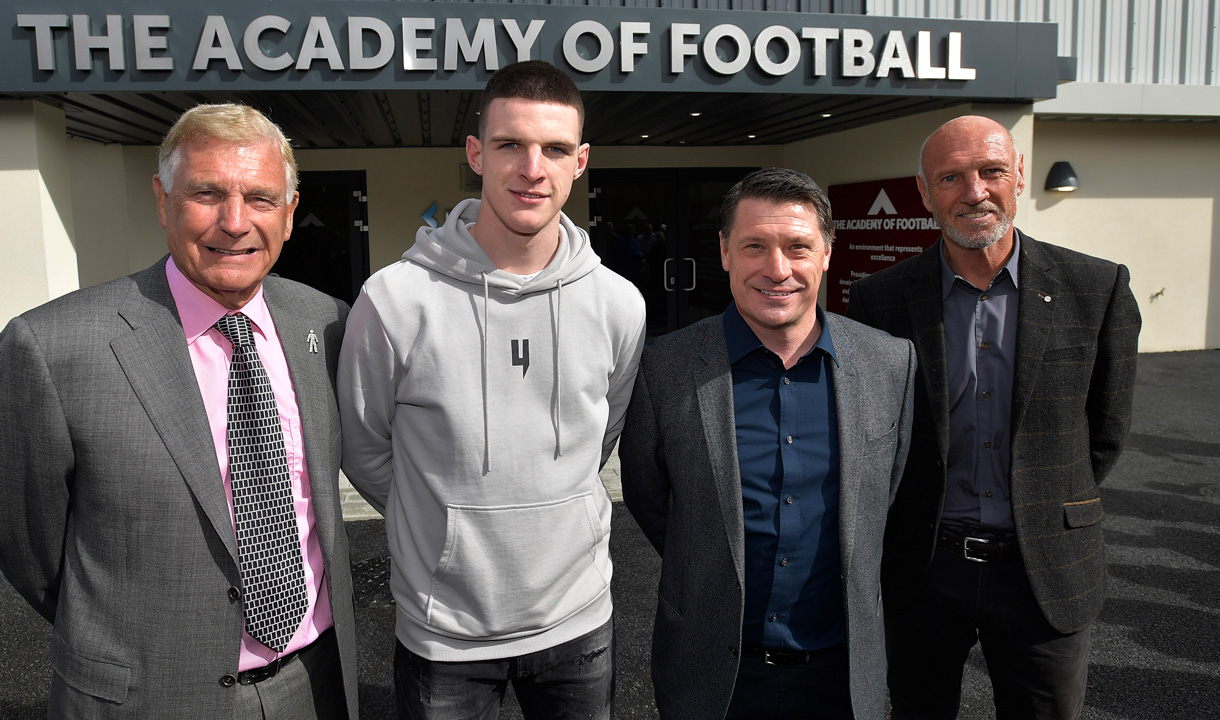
[916,117,1025,250]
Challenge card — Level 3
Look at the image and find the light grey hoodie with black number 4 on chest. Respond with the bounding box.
[338,200,644,661]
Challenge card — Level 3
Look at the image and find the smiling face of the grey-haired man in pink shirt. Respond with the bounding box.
[153,138,298,310]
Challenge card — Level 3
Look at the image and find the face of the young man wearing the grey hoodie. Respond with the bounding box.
[466,98,589,248]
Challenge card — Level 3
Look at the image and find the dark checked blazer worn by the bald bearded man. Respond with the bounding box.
[848,233,1139,632]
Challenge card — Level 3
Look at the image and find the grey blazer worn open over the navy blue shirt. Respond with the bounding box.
[619,312,915,720]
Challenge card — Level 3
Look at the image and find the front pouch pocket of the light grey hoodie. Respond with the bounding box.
[426,493,610,639]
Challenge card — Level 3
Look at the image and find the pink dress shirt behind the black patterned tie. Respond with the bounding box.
[165,257,334,670]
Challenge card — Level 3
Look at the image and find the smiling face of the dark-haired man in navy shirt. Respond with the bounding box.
[720,198,831,347]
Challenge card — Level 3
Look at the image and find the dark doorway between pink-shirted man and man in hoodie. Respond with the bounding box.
[272,170,368,305]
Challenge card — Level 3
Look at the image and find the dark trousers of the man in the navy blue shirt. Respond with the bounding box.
[725,646,852,720]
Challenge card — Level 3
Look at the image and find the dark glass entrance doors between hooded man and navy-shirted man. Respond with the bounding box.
[589,167,755,337]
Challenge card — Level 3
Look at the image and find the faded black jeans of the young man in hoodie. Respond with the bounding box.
[394,621,614,720]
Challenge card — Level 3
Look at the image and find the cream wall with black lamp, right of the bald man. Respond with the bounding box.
[1026,121,1220,351]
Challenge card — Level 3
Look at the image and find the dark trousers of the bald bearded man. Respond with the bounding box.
[886,547,1091,720]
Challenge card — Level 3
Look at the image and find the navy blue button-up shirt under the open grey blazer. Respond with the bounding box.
[725,304,847,650]
